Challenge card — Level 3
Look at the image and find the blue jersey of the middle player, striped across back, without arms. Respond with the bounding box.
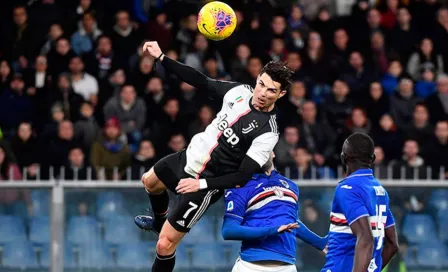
[224,171,299,264]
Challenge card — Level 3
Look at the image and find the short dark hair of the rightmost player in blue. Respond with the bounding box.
[343,132,375,164]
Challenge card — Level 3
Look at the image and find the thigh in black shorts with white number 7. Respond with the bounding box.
[168,190,222,232]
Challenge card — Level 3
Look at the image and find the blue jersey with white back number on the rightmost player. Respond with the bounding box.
[321,169,395,272]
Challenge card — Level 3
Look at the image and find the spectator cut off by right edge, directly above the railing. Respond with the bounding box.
[424,120,448,179]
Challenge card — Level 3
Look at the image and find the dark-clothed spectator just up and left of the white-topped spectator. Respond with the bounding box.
[48,37,76,79]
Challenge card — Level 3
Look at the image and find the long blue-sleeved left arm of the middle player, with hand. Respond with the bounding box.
[222,217,298,241]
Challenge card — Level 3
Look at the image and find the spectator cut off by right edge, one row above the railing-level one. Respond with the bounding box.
[426,73,448,124]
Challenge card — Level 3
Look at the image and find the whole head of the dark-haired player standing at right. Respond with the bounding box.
[341,133,375,173]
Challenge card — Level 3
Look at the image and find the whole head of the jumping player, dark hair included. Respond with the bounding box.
[252,61,293,111]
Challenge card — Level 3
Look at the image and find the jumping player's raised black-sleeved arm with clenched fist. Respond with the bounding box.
[143,42,239,97]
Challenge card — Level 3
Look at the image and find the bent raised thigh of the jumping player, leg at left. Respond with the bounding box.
[149,151,186,192]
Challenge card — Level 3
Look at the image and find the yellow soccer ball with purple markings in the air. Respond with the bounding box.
[197,1,236,41]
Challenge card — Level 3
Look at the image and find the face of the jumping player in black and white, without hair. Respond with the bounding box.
[252,73,286,111]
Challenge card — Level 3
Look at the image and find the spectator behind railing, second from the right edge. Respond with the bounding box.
[394,140,427,179]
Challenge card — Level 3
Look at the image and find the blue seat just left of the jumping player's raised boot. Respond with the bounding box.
[104,215,140,244]
